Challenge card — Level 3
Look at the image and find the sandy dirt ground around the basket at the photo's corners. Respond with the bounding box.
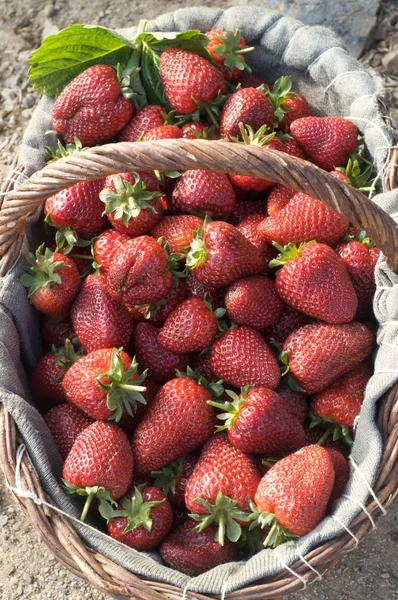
[0,0,398,600]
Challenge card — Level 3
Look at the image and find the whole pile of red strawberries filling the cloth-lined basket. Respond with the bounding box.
[21,25,379,574]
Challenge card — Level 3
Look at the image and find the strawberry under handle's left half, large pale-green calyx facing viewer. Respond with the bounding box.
[100,171,162,236]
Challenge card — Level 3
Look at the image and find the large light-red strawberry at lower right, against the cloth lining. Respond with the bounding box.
[255,445,334,547]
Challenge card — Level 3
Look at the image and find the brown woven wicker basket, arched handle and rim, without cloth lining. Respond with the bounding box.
[0,124,398,600]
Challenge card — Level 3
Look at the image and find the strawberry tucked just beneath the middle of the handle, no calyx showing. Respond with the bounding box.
[171,169,235,218]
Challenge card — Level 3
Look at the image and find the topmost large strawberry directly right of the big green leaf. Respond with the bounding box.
[160,48,225,115]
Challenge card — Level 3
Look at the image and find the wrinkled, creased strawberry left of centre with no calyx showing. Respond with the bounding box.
[106,235,172,308]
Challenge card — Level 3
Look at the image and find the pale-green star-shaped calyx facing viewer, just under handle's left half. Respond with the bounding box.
[100,173,162,227]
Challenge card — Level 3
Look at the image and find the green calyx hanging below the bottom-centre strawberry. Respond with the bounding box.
[189,492,249,546]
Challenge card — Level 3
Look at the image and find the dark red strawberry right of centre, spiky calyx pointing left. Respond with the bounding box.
[209,386,305,455]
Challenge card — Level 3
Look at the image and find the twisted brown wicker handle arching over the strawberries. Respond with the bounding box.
[0,139,398,271]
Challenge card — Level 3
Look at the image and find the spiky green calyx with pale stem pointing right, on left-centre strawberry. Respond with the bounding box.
[96,348,147,423]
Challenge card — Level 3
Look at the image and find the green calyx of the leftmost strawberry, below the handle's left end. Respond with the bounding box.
[20,244,67,299]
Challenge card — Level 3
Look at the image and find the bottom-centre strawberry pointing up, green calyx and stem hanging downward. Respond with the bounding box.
[185,433,260,546]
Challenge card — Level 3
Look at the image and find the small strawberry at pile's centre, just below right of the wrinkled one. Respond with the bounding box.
[158,298,221,352]
